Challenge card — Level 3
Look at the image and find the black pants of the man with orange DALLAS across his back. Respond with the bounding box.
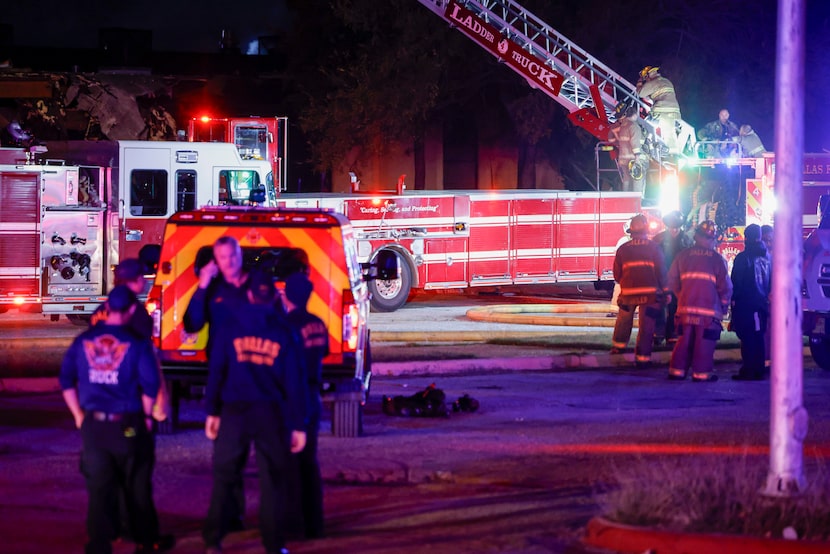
[202,402,291,552]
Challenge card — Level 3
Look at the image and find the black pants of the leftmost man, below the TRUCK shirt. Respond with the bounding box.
[80,414,159,554]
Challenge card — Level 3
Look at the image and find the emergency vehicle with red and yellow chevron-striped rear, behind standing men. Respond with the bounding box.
[147,206,398,437]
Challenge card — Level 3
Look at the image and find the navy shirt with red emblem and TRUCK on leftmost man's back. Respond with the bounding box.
[58,323,161,414]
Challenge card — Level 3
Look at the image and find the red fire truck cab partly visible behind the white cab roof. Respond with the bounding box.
[187,115,288,190]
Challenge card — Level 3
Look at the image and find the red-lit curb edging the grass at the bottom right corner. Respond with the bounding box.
[583,517,830,554]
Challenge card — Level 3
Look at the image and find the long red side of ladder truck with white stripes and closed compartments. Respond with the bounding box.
[278,190,640,306]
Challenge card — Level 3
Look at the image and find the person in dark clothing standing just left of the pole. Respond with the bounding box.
[732,223,772,381]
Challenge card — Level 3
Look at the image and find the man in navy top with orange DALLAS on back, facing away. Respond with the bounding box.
[202,271,308,552]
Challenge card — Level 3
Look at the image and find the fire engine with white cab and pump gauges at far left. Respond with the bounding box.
[0,141,276,321]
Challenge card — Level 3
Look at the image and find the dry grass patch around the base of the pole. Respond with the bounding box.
[599,456,830,541]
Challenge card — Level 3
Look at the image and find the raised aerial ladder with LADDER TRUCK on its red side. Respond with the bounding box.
[418,0,694,164]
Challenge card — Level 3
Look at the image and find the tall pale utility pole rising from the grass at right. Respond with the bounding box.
[763,0,808,496]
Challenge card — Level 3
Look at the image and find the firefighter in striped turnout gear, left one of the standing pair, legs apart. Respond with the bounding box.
[611,214,666,368]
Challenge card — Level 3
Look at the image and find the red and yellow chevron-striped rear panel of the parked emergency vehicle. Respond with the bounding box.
[156,218,351,361]
